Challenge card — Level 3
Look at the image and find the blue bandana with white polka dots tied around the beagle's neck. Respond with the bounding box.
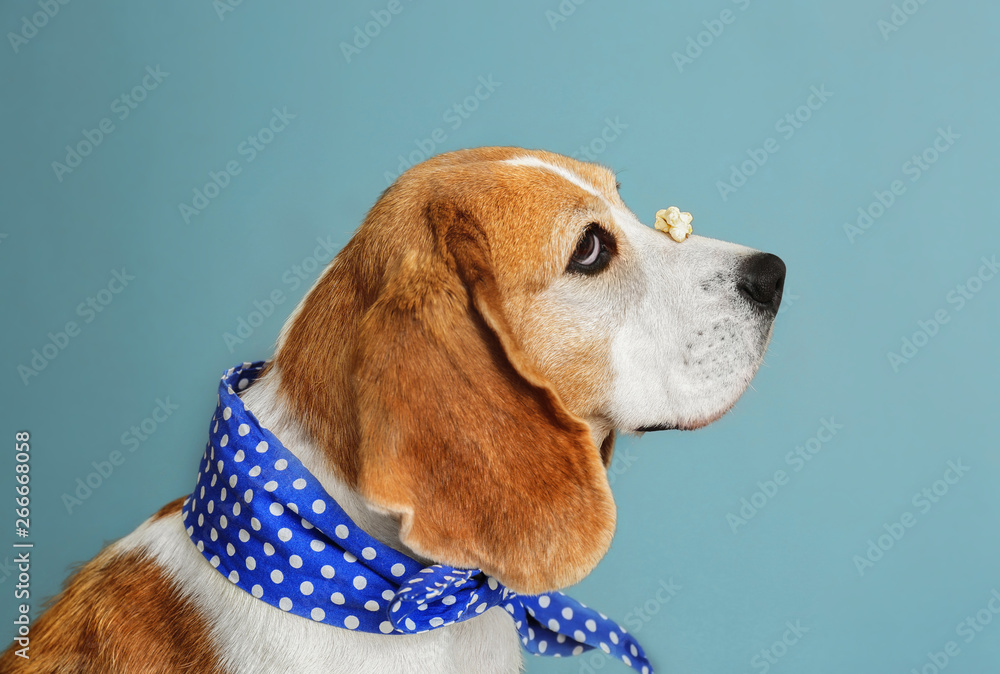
[183,362,652,674]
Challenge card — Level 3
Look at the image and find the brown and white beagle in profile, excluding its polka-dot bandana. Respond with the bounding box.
[0,147,785,674]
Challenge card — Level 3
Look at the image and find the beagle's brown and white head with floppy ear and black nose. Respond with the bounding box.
[275,148,784,593]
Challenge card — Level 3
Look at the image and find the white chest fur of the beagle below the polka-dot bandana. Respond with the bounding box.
[143,515,522,674]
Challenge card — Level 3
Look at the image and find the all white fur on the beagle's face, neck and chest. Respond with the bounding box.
[109,158,770,674]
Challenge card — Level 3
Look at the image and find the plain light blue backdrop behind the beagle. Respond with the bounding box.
[0,0,1000,674]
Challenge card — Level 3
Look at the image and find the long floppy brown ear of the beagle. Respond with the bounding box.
[354,203,615,594]
